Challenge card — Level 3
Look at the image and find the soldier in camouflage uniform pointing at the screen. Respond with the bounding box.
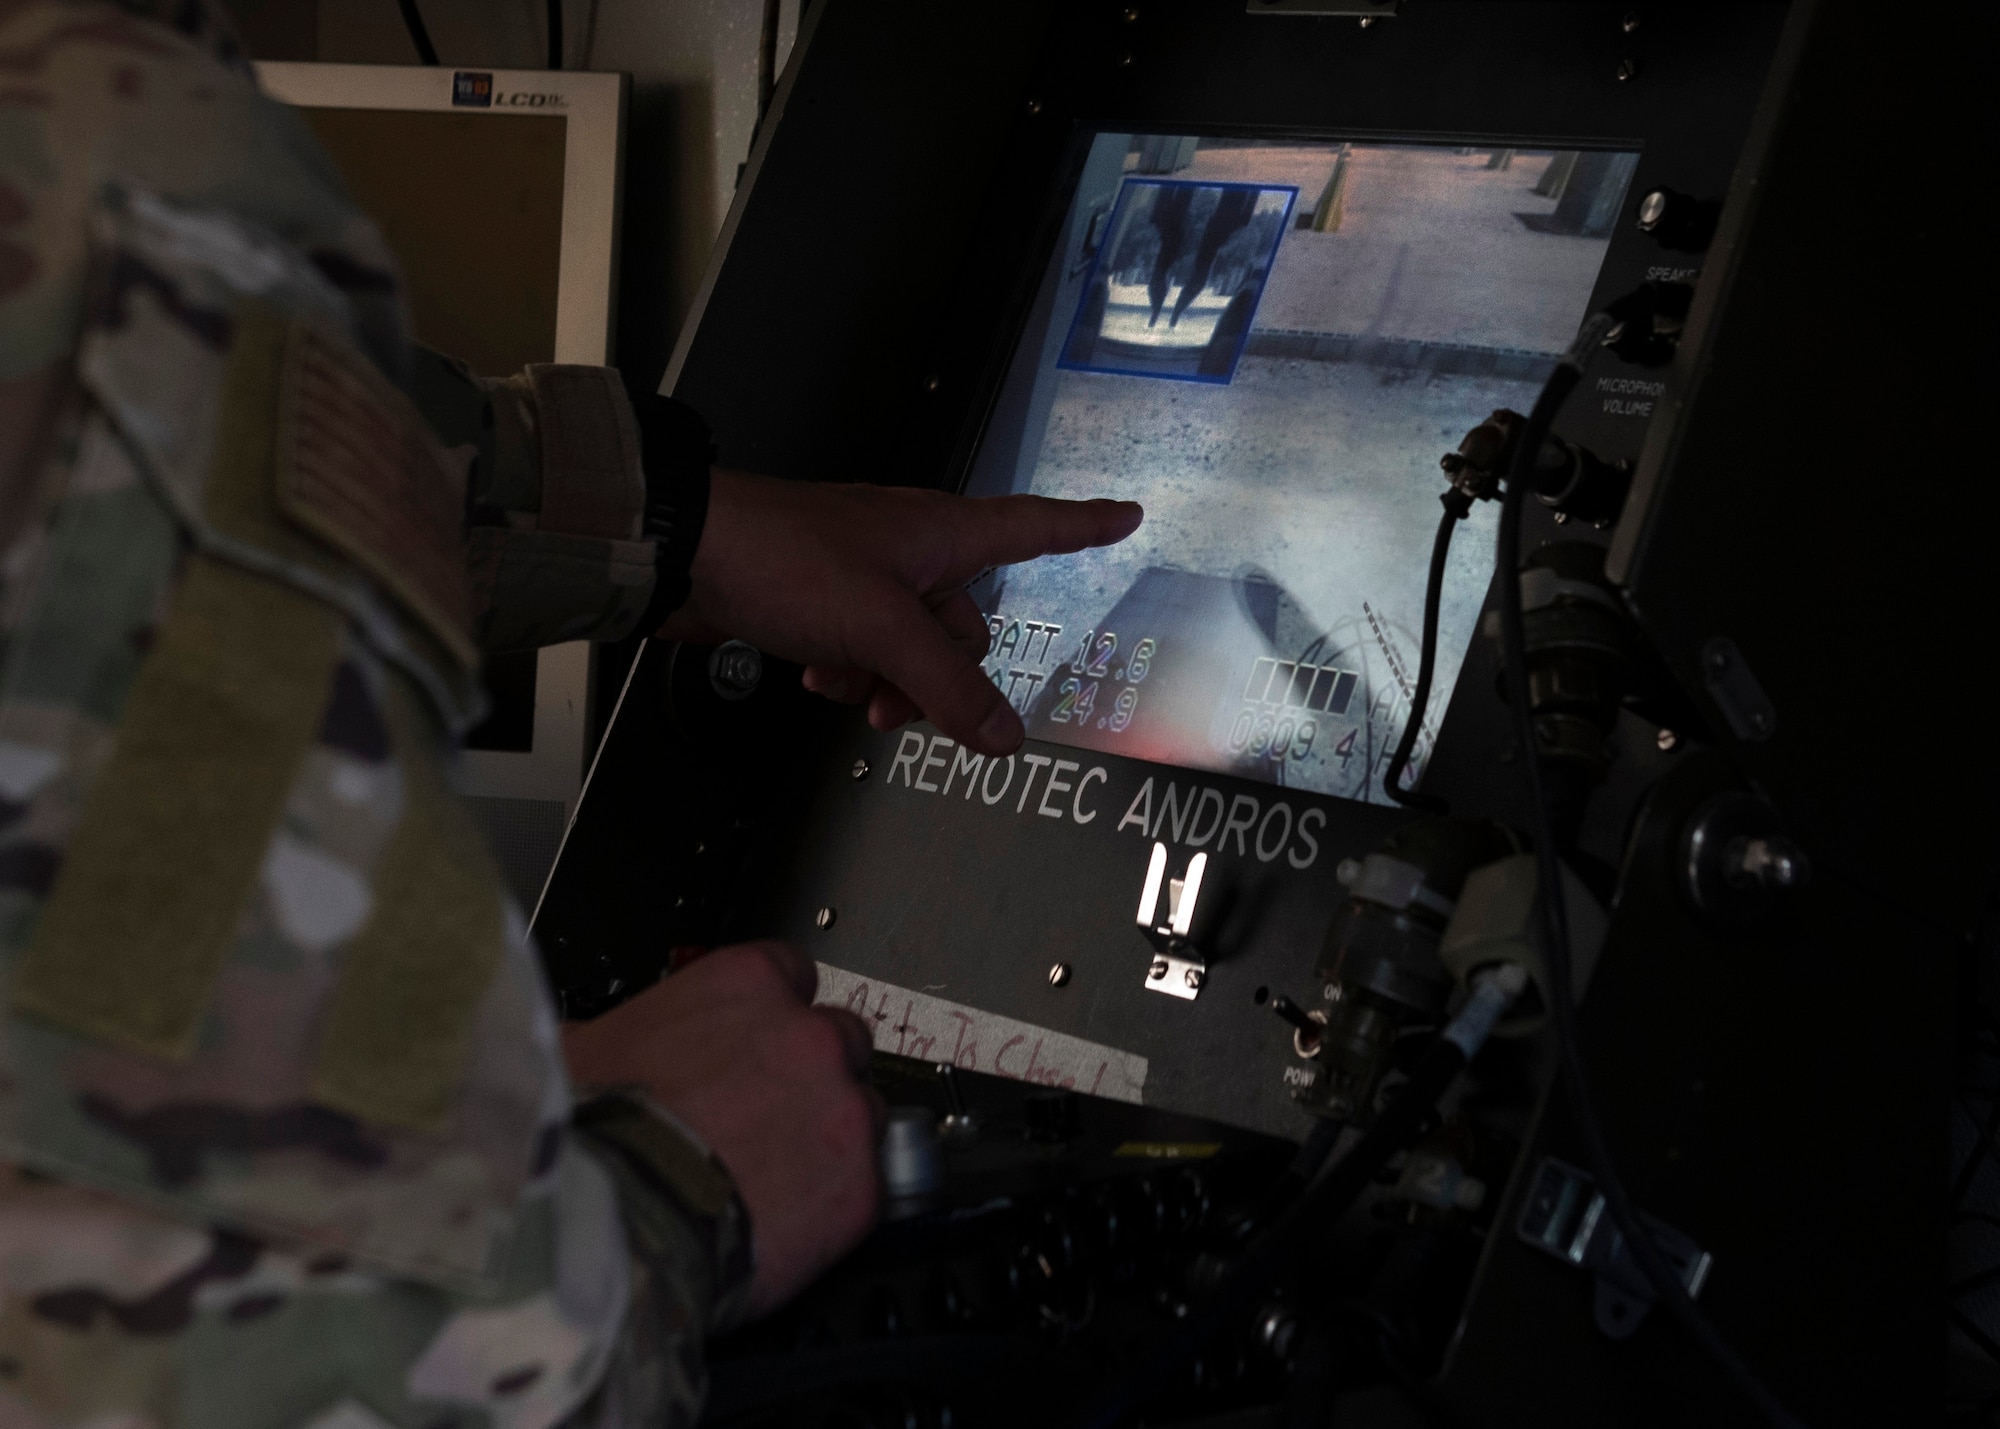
[0,0,1138,1429]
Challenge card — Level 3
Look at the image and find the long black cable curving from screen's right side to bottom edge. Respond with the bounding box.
[1498,314,1804,1429]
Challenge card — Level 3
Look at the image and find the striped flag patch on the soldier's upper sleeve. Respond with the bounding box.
[278,324,478,670]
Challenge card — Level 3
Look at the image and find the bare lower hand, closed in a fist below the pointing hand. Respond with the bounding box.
[562,943,882,1313]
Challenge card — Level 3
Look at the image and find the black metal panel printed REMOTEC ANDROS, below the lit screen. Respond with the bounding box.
[774,725,1406,1135]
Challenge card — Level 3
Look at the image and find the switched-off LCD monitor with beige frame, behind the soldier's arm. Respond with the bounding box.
[256,64,624,909]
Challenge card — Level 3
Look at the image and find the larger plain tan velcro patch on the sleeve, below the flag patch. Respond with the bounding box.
[12,556,340,1061]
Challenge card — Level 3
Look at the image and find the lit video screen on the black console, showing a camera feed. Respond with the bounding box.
[966,134,1638,803]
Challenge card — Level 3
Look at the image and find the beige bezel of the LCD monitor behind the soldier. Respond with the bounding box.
[256,62,626,827]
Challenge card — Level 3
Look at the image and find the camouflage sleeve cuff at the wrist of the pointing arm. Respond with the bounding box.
[410,348,654,650]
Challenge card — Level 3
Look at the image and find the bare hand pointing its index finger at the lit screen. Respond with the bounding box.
[660,468,1144,755]
